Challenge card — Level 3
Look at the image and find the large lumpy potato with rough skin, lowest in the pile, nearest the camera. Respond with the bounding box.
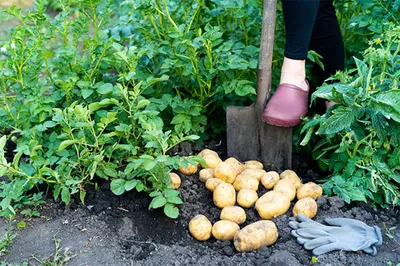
[233,220,278,252]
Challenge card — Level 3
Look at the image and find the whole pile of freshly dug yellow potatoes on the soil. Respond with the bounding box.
[171,149,322,252]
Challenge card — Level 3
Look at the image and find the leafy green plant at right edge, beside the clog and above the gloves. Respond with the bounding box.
[301,24,400,206]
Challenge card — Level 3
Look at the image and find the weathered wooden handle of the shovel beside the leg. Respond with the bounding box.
[256,0,277,109]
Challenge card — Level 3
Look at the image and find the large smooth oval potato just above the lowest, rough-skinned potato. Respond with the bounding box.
[256,190,290,220]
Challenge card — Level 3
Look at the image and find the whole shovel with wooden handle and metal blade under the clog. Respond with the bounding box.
[226,0,292,171]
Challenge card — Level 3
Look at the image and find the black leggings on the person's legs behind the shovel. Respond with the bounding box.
[282,0,344,80]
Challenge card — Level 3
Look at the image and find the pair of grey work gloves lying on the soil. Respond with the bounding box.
[289,214,382,256]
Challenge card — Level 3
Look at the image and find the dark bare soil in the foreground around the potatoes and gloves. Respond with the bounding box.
[0,140,400,266]
